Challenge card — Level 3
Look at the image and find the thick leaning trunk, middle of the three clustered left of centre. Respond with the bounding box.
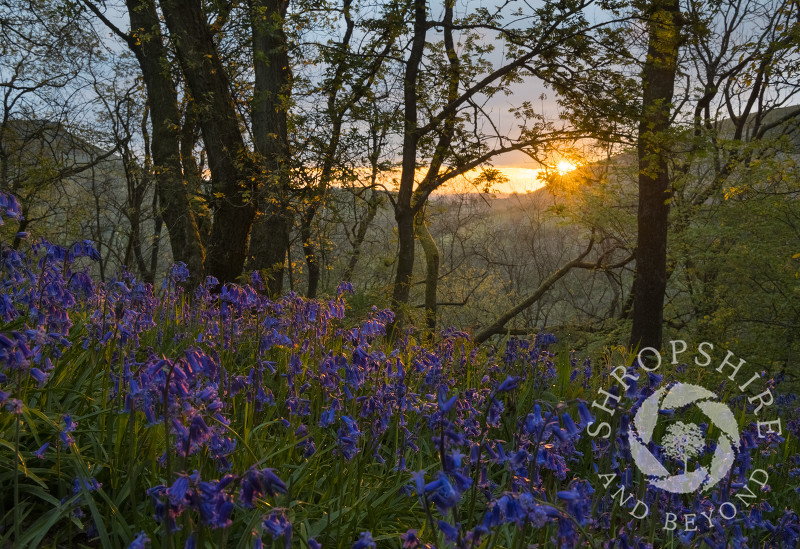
[161,0,260,282]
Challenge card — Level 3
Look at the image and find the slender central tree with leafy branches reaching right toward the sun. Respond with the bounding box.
[392,0,612,330]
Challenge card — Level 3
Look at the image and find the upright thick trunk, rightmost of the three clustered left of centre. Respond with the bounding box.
[250,0,292,296]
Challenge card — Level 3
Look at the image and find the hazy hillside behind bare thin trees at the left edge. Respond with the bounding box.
[0,119,168,274]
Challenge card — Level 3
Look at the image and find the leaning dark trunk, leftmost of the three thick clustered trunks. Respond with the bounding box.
[127,0,205,282]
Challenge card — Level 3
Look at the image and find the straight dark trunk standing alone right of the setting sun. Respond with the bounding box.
[630,0,681,349]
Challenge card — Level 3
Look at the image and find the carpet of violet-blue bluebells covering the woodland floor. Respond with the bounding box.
[0,186,800,549]
